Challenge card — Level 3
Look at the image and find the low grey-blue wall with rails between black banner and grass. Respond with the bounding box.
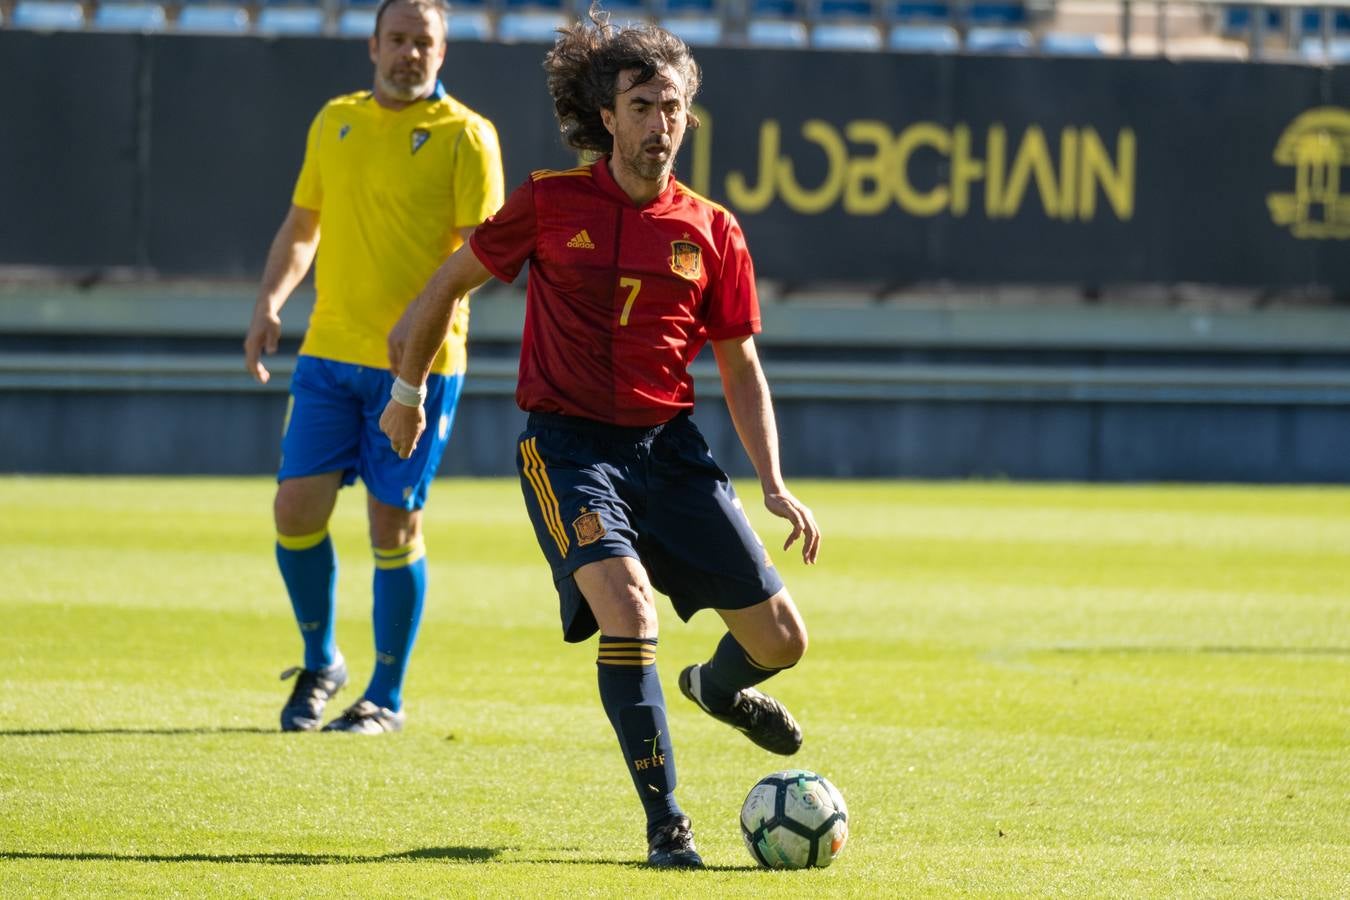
[0,289,1350,483]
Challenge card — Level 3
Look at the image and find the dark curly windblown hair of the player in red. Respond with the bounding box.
[544,1,702,154]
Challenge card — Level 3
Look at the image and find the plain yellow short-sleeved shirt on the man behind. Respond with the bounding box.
[292,84,502,374]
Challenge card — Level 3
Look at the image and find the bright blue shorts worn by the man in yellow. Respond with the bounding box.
[277,356,464,510]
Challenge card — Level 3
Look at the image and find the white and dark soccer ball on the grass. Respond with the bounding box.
[741,769,848,869]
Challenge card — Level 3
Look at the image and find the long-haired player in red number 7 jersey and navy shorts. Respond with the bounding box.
[381,7,821,868]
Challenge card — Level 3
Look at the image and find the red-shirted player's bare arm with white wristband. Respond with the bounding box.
[379,244,491,459]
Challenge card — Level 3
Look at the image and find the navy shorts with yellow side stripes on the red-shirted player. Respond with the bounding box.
[516,413,783,641]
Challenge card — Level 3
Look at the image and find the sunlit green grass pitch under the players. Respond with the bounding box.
[0,478,1350,899]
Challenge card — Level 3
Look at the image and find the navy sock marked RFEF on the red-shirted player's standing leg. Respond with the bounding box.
[595,634,683,837]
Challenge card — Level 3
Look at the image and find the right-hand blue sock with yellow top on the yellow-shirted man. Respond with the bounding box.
[366,537,427,712]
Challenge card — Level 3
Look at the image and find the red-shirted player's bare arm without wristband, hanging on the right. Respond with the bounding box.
[713,335,821,564]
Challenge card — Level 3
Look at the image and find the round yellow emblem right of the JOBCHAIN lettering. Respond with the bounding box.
[1266,107,1350,240]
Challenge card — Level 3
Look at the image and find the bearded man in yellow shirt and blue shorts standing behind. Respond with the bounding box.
[244,0,502,734]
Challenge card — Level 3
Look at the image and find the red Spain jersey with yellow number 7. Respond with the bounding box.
[470,158,760,425]
